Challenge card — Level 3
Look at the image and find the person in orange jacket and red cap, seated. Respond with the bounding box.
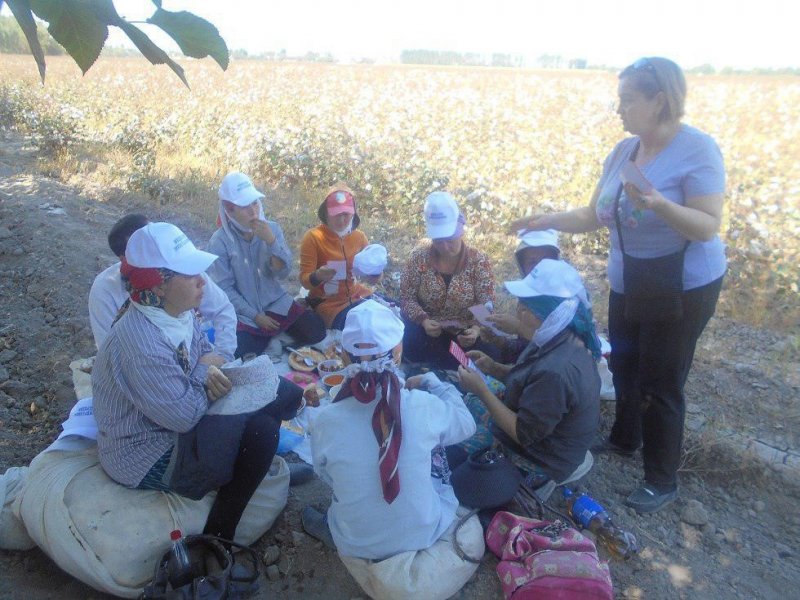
[300,183,371,329]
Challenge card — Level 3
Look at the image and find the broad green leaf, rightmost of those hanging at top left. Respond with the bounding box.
[147,8,230,71]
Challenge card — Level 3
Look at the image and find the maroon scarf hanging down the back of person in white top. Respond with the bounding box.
[333,371,403,504]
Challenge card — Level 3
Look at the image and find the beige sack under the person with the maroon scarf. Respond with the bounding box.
[340,508,484,600]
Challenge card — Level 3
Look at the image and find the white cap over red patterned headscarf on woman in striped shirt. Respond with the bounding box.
[125,223,218,275]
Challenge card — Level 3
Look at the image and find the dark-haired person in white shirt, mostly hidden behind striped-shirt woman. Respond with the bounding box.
[89,214,236,360]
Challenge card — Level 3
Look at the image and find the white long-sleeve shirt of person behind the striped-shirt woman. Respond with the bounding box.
[89,262,236,359]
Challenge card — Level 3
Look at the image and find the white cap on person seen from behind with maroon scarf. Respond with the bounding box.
[342,300,405,356]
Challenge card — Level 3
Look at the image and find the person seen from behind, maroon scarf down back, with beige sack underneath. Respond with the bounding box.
[302,300,483,598]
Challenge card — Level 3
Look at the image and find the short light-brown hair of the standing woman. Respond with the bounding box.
[619,56,686,121]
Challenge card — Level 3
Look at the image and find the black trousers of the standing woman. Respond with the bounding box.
[608,277,723,492]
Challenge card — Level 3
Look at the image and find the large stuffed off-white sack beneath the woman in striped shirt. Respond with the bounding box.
[15,445,289,598]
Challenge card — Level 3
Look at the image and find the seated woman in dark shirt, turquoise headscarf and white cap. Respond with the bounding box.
[459,259,600,497]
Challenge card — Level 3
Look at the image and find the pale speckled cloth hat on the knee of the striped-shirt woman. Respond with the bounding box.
[206,354,278,415]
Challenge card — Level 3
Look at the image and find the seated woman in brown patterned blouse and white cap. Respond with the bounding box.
[400,192,499,369]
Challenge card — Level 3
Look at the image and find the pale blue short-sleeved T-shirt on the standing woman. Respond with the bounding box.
[596,125,727,293]
